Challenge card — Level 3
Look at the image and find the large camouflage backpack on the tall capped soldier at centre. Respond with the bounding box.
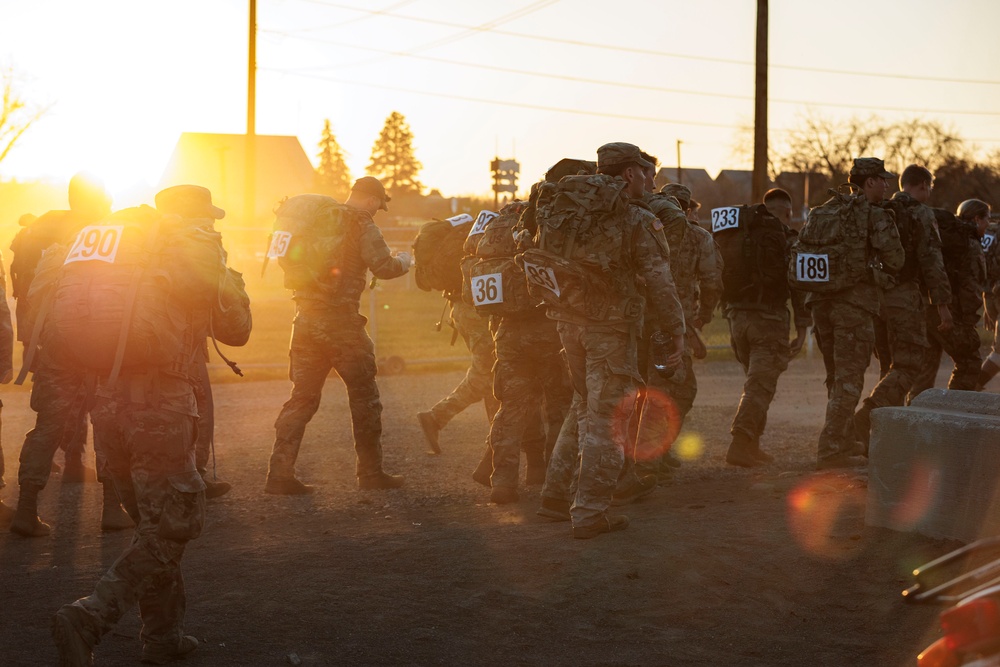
[516,174,643,323]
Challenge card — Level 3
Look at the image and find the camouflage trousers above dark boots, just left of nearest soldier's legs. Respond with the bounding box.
[17,364,96,489]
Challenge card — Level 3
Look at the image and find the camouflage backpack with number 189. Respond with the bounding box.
[788,186,872,293]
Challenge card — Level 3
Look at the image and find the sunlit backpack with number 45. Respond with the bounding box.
[261,194,354,290]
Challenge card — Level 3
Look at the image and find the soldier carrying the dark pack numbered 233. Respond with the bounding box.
[724,188,811,468]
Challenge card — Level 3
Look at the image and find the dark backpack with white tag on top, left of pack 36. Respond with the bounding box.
[413,213,482,295]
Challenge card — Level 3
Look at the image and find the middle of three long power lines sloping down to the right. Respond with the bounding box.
[261,30,1000,116]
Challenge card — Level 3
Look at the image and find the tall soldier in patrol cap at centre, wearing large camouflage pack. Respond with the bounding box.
[524,143,684,539]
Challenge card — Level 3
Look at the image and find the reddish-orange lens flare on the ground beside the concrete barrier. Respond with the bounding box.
[787,474,866,559]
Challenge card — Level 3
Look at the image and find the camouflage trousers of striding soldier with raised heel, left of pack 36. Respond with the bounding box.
[431,300,500,428]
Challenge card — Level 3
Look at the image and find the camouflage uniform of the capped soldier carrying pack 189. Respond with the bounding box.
[806,206,904,464]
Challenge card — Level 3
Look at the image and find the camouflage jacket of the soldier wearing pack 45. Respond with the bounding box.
[292,207,406,312]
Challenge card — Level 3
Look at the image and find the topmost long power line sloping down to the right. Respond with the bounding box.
[288,0,1000,86]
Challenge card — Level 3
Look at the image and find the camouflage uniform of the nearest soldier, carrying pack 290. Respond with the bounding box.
[57,200,251,655]
